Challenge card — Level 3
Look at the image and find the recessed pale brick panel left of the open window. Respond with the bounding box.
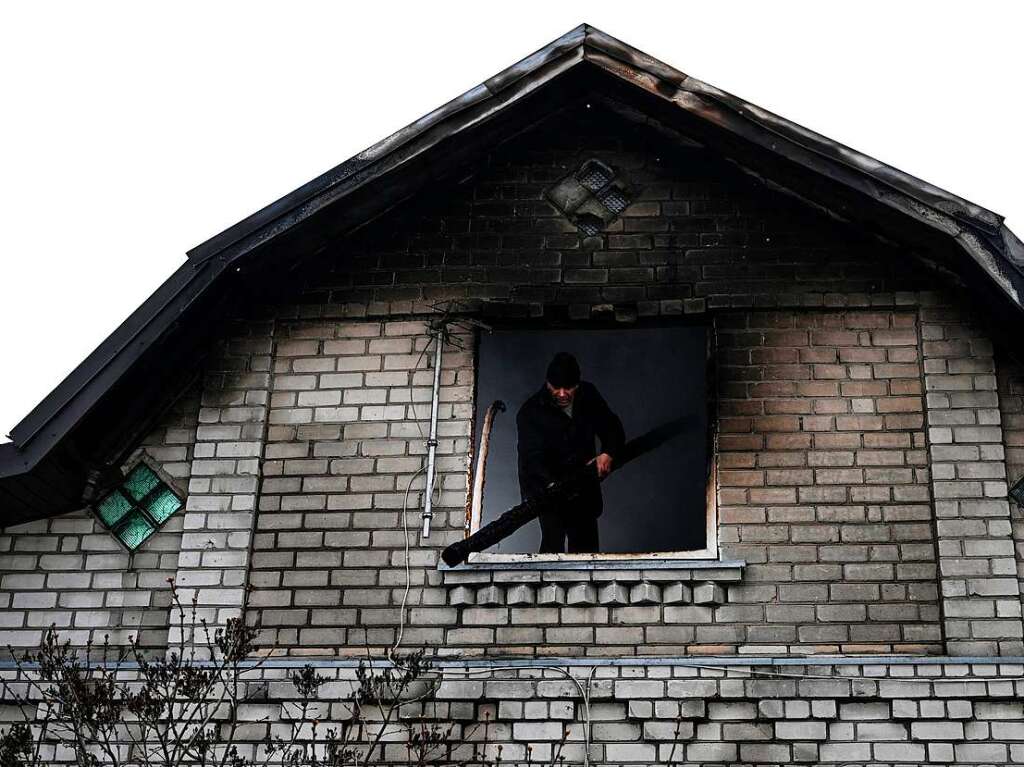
[250,321,473,654]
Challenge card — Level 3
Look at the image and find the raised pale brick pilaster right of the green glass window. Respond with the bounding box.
[171,321,273,647]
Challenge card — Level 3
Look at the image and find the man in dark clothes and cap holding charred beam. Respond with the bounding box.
[516,351,626,554]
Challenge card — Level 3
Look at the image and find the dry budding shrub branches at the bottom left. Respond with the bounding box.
[0,582,588,767]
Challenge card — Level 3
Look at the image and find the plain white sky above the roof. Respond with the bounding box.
[0,0,1024,442]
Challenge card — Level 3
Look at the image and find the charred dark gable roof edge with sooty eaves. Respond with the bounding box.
[0,25,1024,525]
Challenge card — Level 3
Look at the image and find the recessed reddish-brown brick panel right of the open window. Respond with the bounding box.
[718,310,941,652]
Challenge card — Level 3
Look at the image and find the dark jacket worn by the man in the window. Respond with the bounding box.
[516,381,626,517]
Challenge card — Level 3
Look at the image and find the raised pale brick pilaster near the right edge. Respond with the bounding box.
[921,305,1024,655]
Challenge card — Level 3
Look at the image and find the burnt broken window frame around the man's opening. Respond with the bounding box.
[464,317,721,567]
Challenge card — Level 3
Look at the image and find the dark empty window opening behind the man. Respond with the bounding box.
[470,326,717,561]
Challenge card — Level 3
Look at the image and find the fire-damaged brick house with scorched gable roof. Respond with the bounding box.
[0,27,1024,765]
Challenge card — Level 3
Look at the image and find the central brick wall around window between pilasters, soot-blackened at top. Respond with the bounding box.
[235,105,962,654]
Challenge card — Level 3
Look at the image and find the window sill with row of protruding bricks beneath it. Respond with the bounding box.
[438,555,746,607]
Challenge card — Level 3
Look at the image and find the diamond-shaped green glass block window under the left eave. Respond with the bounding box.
[95,463,181,551]
